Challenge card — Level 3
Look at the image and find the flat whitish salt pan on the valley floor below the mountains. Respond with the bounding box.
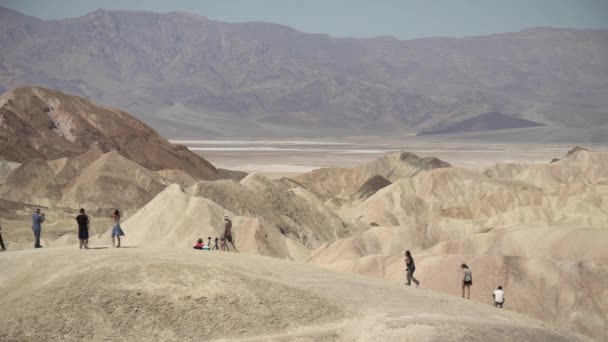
[179,136,608,176]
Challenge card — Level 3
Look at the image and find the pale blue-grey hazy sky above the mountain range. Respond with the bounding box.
[0,0,608,39]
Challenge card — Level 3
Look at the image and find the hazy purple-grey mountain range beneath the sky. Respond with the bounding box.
[0,9,608,141]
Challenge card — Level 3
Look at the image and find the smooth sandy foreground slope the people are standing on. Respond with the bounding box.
[0,248,585,342]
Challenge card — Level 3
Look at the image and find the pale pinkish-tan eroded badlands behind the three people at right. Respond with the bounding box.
[309,149,608,340]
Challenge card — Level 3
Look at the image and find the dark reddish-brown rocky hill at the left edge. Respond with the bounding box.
[0,86,218,179]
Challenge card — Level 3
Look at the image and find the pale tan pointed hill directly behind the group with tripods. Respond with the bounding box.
[105,174,360,260]
